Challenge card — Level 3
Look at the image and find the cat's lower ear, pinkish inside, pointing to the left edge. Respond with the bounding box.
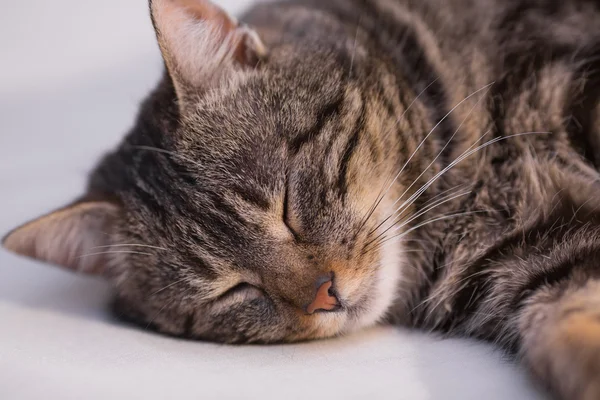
[2,201,120,275]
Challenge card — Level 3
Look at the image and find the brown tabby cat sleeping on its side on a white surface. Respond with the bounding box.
[4,0,600,400]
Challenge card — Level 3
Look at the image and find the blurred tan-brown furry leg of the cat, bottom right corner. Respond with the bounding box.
[519,280,600,400]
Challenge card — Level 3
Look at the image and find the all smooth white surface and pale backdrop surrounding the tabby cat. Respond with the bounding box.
[0,0,541,400]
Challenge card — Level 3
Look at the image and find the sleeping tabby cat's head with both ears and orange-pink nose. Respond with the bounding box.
[4,0,400,343]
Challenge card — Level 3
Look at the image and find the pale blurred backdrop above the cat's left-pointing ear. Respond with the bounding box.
[0,0,250,232]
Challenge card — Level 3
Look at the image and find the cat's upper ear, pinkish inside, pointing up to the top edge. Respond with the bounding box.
[150,0,267,96]
